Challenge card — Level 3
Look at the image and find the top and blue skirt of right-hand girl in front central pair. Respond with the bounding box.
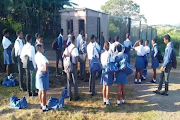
[115,52,128,84]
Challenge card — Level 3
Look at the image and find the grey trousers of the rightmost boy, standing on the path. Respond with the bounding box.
[158,63,172,91]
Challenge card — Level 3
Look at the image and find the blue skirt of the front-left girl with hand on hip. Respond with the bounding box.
[36,70,49,90]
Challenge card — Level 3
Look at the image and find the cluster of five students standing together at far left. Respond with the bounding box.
[2,29,49,111]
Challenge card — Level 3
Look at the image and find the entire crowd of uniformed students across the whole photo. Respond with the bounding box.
[2,26,173,111]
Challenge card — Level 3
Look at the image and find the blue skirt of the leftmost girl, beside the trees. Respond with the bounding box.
[4,48,12,65]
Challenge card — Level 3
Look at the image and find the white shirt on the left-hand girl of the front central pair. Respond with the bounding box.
[101,50,112,66]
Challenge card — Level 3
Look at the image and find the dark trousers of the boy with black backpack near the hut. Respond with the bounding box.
[56,50,64,73]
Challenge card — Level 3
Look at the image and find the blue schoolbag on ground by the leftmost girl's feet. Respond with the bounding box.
[2,78,18,87]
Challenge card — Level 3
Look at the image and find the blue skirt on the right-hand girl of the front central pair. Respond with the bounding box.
[115,71,128,84]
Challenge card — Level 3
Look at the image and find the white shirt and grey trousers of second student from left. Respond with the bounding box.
[14,37,24,89]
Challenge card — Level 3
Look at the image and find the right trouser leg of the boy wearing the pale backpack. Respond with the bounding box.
[72,65,78,98]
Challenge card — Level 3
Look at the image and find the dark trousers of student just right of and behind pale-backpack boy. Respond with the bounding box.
[79,53,87,79]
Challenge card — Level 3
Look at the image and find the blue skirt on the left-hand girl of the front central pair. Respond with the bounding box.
[100,72,114,86]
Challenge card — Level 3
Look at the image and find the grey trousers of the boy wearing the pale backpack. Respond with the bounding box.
[67,65,78,98]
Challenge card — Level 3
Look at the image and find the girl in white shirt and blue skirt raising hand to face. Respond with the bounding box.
[133,40,146,84]
